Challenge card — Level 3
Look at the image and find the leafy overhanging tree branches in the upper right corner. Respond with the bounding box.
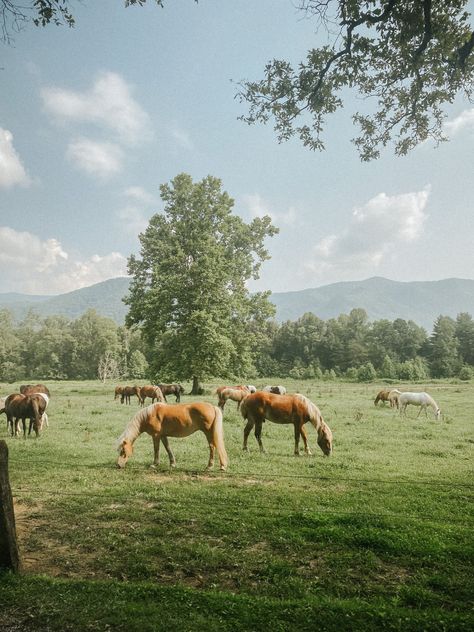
[239,0,474,160]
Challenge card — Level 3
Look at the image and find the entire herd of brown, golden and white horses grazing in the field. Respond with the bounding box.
[0,384,441,470]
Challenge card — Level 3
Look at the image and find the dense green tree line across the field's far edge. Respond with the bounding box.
[0,308,474,382]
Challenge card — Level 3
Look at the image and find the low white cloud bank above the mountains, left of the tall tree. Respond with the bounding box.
[0,226,127,294]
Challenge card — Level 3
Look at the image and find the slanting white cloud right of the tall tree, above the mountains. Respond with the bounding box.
[307,187,430,280]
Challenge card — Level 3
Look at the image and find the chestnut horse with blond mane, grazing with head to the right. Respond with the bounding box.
[240,391,332,456]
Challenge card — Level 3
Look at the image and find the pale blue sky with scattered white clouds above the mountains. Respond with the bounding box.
[0,0,474,295]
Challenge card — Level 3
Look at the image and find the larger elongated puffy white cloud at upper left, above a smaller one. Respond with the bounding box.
[41,72,150,144]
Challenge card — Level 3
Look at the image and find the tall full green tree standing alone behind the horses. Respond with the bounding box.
[125,174,277,390]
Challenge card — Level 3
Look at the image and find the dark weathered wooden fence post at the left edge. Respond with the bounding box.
[0,441,21,572]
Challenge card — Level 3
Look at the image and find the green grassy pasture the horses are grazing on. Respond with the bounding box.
[0,380,474,632]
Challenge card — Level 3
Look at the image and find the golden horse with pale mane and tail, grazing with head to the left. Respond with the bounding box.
[116,402,228,471]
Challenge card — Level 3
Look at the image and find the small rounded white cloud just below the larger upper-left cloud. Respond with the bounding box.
[66,138,123,178]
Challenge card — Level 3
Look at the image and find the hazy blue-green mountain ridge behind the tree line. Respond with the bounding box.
[0,277,474,331]
